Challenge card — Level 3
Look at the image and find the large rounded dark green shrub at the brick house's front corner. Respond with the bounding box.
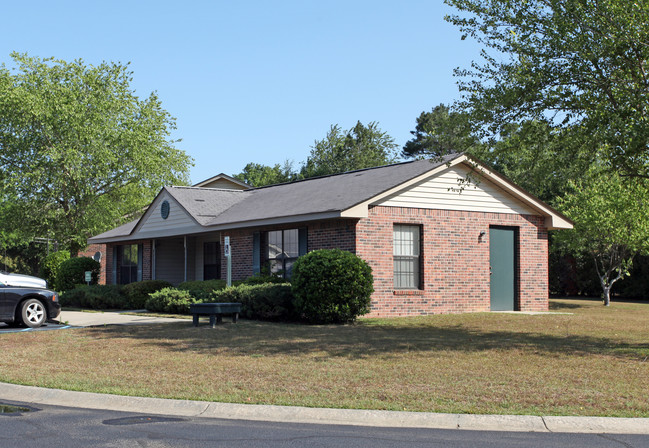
[291,249,374,323]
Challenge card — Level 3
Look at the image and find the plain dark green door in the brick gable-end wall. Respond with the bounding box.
[489,227,516,311]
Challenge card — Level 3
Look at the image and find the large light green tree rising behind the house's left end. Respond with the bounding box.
[0,53,191,254]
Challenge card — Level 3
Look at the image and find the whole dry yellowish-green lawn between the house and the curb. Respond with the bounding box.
[0,300,649,417]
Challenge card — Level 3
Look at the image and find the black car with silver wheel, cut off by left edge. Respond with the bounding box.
[0,278,61,328]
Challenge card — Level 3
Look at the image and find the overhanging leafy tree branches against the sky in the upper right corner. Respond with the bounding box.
[445,0,649,177]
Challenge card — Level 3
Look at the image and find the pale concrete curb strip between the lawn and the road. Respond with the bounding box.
[0,383,649,434]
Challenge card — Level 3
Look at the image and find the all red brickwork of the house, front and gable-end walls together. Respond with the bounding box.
[95,206,548,317]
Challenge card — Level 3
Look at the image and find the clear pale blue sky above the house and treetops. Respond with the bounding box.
[0,0,479,183]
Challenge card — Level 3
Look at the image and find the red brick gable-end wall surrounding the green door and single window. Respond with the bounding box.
[356,207,548,317]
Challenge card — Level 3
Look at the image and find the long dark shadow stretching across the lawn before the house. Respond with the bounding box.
[87,321,649,361]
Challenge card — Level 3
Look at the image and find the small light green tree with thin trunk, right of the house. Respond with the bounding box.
[555,174,649,306]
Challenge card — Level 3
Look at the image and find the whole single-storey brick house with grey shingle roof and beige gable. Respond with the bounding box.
[87,154,572,316]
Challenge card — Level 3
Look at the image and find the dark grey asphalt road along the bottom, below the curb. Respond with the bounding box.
[0,402,649,448]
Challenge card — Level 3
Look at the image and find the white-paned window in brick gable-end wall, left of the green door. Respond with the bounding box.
[393,224,421,289]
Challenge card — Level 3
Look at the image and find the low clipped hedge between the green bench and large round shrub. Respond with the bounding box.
[209,283,296,320]
